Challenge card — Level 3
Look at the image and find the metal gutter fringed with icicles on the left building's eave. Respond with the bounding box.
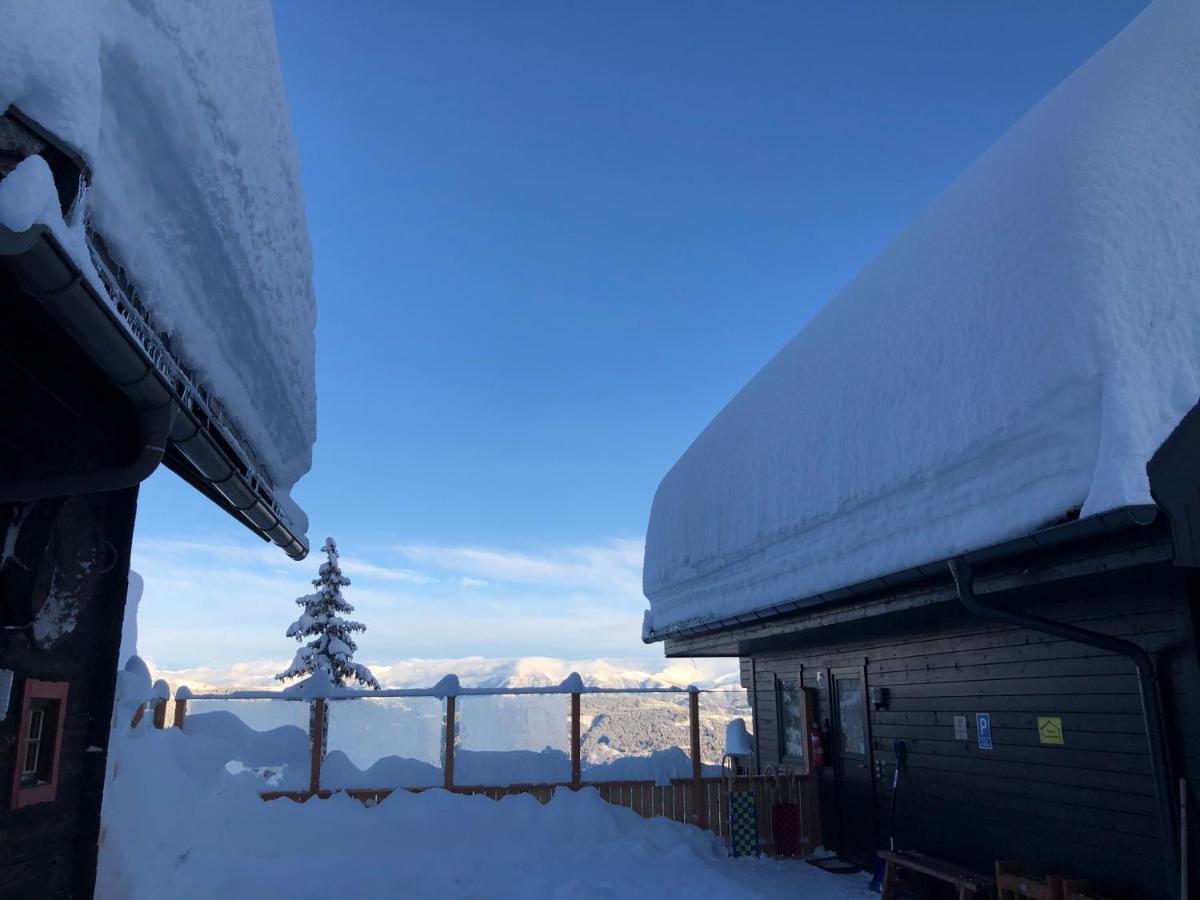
[0,224,308,559]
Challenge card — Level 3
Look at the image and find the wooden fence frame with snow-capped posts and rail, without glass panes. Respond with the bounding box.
[138,672,820,852]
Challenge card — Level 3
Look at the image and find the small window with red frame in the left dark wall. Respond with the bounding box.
[8,678,67,809]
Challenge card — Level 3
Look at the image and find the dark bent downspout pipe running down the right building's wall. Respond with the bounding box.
[949,557,1180,900]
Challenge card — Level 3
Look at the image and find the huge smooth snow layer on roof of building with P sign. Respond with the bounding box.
[644,0,1200,636]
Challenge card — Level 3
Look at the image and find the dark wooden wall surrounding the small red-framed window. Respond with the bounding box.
[0,487,137,900]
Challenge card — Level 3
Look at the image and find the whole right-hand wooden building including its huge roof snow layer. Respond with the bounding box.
[643,0,1200,900]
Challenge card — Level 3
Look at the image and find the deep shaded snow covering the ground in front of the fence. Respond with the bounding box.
[96,658,871,900]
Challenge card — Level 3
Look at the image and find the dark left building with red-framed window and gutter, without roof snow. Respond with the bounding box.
[0,108,307,899]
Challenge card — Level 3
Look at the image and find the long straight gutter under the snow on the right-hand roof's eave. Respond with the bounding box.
[642,504,1158,643]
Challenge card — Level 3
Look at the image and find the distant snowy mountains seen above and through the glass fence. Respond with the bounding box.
[162,656,750,769]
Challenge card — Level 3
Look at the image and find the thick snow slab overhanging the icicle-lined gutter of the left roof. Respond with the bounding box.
[0,0,316,494]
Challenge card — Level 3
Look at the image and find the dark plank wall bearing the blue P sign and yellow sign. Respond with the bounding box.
[742,565,1200,898]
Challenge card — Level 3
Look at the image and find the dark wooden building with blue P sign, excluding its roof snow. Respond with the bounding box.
[666,441,1200,899]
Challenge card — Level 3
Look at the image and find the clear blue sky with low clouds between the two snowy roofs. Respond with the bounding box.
[126,0,1145,668]
